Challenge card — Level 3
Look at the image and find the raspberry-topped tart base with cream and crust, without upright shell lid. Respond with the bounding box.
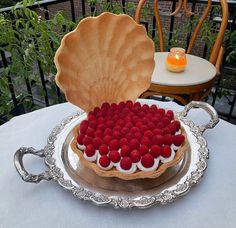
[71,101,188,180]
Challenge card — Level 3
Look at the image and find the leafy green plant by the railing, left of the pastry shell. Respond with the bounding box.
[0,0,75,118]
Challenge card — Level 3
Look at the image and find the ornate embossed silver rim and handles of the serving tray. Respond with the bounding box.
[15,100,219,208]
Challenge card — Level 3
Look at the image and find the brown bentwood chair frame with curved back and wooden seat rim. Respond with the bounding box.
[135,0,228,104]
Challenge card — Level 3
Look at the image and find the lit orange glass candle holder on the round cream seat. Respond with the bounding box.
[166,48,187,72]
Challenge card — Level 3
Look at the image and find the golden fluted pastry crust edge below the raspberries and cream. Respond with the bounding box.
[71,125,189,180]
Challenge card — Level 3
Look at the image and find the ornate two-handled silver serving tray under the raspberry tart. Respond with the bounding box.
[14,100,219,208]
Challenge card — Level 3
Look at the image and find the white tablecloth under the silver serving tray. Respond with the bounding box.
[0,102,236,228]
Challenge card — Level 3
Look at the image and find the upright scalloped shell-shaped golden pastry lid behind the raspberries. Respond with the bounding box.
[54,13,155,112]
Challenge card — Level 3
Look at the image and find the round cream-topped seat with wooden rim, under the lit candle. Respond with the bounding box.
[142,52,216,104]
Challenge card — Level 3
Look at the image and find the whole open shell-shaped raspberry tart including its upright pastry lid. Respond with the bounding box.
[55,13,188,180]
